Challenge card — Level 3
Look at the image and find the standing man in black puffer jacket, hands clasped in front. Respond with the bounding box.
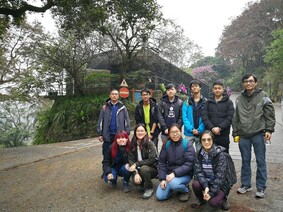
[202,80,234,153]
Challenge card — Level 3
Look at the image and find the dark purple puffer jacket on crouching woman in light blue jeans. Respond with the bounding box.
[158,138,196,181]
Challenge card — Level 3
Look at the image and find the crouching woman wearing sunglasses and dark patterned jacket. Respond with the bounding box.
[191,130,231,210]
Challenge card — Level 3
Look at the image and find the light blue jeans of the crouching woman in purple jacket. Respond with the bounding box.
[156,175,191,201]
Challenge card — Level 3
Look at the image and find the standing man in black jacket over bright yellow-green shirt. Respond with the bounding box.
[135,88,160,150]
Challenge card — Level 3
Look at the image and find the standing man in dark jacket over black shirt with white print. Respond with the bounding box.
[157,83,183,141]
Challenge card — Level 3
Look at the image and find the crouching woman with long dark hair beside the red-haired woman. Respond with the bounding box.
[127,124,158,199]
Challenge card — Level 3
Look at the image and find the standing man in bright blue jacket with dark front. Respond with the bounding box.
[182,80,206,152]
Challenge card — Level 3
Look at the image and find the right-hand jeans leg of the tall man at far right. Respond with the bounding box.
[252,133,267,190]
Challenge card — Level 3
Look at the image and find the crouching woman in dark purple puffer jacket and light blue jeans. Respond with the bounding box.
[156,124,195,202]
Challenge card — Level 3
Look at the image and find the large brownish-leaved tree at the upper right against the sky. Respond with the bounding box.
[216,0,283,77]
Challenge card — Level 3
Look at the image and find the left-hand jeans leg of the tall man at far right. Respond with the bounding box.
[239,138,252,188]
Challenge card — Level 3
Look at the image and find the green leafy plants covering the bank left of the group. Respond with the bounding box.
[34,95,108,144]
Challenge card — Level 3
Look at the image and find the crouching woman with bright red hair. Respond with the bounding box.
[102,131,131,192]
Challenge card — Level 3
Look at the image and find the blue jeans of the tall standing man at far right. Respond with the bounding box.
[239,133,267,190]
